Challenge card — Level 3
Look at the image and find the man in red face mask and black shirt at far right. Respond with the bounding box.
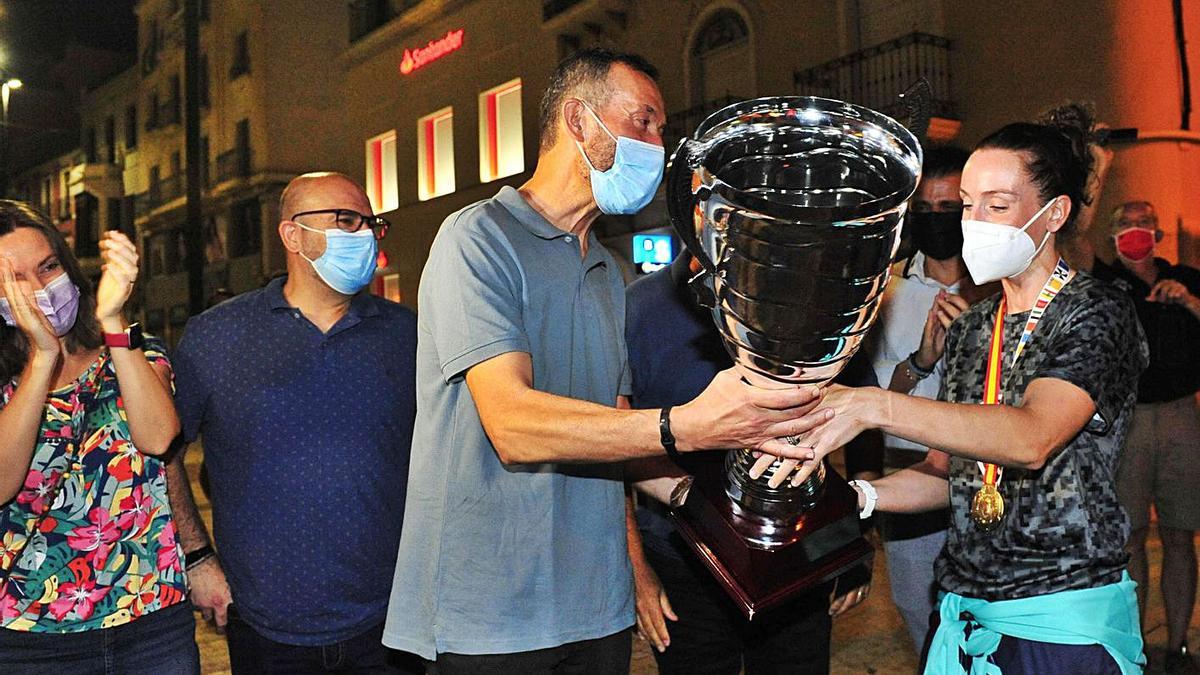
[1092,201,1200,673]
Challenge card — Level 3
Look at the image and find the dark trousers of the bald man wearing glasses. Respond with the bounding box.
[226,605,424,675]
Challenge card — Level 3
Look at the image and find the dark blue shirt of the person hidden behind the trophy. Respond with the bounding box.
[625,255,883,556]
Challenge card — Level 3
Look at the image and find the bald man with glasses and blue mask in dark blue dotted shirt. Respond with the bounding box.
[168,173,419,674]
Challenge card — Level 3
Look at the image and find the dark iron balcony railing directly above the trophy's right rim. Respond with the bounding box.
[792,32,958,119]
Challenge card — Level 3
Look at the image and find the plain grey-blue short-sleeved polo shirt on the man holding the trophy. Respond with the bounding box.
[383,187,634,658]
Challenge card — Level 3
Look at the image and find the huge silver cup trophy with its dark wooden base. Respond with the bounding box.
[666,90,928,616]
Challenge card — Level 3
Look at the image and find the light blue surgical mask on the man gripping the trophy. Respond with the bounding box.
[575,103,666,215]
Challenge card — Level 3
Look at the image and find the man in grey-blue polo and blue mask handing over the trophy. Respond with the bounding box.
[384,49,826,675]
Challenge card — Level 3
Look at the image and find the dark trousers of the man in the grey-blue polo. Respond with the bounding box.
[425,631,634,675]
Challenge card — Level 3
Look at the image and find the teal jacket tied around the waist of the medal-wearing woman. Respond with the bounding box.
[925,574,1146,675]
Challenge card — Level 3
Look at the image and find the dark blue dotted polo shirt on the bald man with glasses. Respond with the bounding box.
[174,279,416,645]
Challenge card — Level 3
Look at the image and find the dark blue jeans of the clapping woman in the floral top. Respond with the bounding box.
[0,602,200,675]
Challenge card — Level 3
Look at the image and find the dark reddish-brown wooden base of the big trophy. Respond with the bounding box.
[671,454,874,619]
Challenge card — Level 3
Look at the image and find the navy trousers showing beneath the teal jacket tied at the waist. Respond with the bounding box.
[920,611,1121,675]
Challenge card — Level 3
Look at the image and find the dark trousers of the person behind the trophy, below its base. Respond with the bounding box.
[646,534,833,675]
